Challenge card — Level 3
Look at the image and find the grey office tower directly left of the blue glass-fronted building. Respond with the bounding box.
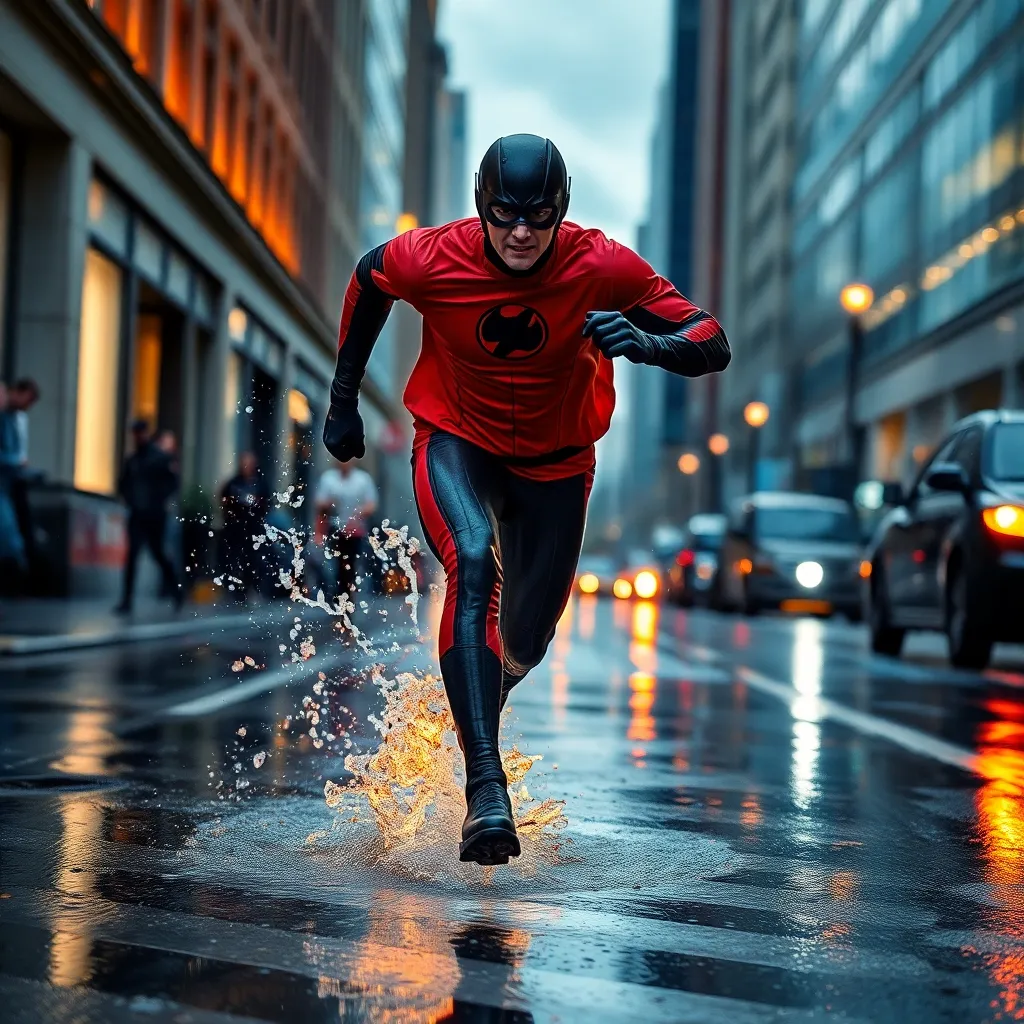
[690,0,800,508]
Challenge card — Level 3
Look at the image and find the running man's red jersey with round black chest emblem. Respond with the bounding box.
[340,218,698,479]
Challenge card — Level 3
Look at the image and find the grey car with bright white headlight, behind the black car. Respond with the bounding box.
[719,492,866,620]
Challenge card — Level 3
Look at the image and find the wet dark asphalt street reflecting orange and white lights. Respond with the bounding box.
[0,599,1024,1024]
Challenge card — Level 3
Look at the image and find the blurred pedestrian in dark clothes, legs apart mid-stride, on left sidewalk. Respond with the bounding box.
[116,420,183,614]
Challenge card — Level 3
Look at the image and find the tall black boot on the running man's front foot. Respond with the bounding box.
[441,646,520,864]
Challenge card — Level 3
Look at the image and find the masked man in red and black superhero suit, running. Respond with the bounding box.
[324,135,730,864]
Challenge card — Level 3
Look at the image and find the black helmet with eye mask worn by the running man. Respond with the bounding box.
[476,135,570,238]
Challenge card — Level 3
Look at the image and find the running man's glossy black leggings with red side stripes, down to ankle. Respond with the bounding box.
[413,433,593,790]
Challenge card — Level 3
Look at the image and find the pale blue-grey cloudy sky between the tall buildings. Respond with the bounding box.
[438,0,669,246]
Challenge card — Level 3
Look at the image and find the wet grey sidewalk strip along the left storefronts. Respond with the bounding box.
[0,598,272,657]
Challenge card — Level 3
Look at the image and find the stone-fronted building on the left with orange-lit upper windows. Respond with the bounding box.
[0,0,394,593]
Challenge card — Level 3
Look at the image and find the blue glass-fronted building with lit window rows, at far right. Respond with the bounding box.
[790,0,1024,476]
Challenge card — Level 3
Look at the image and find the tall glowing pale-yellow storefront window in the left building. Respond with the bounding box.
[75,249,121,495]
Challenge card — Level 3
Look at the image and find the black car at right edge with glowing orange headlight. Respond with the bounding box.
[866,411,1024,669]
